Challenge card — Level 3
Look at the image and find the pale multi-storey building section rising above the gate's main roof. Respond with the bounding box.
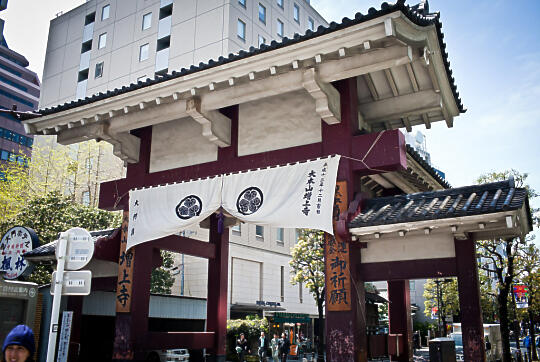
[40,0,327,108]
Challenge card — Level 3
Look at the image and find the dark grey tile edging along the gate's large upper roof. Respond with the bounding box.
[38,0,465,116]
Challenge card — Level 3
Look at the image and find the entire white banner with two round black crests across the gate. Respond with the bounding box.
[127,156,340,250]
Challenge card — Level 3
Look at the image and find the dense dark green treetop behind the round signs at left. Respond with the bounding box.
[0,191,120,284]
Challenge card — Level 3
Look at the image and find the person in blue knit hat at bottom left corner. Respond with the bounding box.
[2,324,36,362]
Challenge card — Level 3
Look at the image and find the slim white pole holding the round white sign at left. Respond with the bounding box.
[47,233,68,362]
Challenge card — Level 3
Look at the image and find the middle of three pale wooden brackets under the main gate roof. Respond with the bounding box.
[186,98,231,147]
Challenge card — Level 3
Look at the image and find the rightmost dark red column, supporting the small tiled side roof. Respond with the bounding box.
[454,240,486,362]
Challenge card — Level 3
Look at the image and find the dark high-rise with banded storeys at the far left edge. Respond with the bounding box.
[0,1,40,167]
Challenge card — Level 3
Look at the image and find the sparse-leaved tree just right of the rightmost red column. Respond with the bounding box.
[477,169,538,362]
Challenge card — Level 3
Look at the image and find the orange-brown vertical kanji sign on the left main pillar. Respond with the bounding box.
[116,211,135,313]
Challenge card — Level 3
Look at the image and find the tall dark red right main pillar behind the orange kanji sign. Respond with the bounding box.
[322,78,367,362]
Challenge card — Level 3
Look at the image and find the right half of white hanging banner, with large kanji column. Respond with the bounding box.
[222,156,339,234]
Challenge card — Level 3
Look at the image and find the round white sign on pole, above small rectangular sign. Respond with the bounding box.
[56,228,94,270]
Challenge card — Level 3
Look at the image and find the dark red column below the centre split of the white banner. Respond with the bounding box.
[206,215,229,362]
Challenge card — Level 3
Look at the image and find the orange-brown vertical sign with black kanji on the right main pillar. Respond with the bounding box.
[324,181,351,312]
